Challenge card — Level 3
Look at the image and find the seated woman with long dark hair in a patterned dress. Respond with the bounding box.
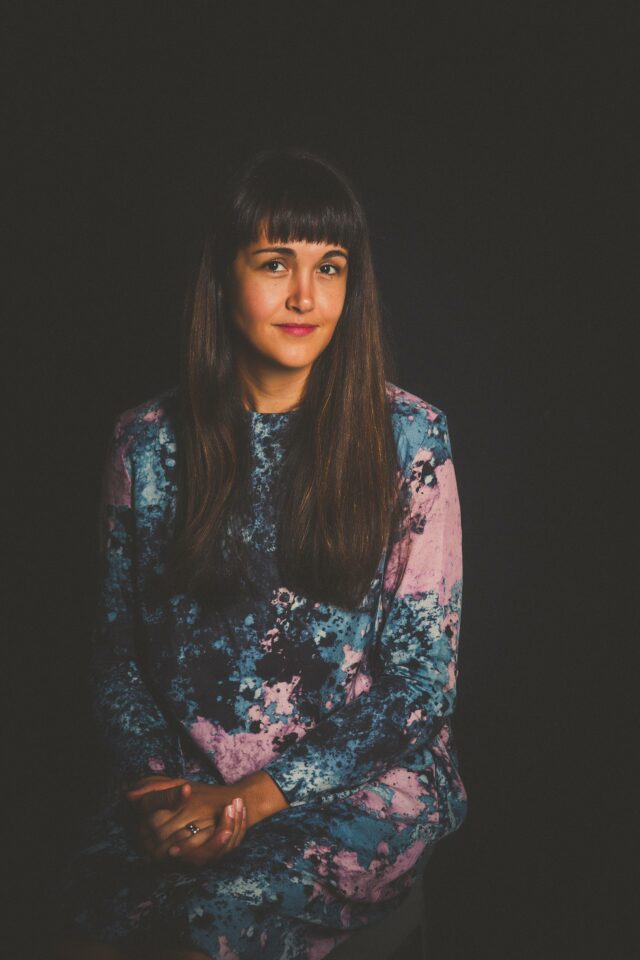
[55,150,466,960]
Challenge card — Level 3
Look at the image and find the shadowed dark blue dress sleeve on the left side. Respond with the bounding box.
[88,415,183,787]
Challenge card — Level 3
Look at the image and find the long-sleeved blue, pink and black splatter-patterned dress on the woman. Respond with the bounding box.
[60,383,467,960]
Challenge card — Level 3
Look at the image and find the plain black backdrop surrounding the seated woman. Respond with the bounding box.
[3,2,638,960]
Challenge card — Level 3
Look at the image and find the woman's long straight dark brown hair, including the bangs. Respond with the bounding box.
[168,148,403,608]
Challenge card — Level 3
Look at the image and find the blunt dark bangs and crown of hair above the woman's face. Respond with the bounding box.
[228,155,363,251]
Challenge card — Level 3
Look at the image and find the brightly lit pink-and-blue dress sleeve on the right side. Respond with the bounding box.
[263,411,462,805]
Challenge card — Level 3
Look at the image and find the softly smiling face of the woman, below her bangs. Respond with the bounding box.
[232,225,348,372]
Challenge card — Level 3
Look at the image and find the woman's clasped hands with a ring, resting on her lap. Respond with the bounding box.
[126,777,248,866]
